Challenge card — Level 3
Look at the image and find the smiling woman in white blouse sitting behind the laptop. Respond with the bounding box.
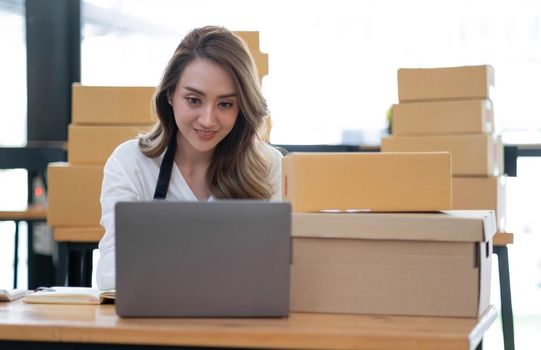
[97,27,282,289]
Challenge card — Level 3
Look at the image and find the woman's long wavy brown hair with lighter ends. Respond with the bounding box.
[139,26,271,199]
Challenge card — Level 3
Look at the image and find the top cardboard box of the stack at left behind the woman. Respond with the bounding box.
[71,84,156,125]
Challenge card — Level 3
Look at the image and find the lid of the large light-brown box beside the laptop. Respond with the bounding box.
[292,210,496,242]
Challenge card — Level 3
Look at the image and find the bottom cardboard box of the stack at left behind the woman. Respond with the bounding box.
[47,163,103,226]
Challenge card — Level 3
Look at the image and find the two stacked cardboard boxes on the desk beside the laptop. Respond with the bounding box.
[282,152,496,317]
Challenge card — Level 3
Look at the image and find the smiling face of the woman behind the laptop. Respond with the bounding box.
[170,59,239,154]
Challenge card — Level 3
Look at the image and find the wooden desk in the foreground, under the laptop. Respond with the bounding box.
[0,300,497,350]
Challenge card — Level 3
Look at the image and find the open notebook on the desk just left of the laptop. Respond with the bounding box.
[23,287,115,305]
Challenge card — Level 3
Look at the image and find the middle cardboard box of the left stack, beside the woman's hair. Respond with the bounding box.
[68,124,150,165]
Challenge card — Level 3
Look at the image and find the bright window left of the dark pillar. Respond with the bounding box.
[0,0,27,288]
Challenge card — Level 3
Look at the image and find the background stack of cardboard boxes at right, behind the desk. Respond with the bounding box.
[381,66,505,231]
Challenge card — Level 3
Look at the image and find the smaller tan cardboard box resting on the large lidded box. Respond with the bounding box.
[282,152,451,212]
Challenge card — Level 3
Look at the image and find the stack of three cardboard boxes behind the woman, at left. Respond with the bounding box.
[47,84,154,241]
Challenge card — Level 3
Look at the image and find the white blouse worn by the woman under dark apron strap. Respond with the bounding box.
[96,139,282,290]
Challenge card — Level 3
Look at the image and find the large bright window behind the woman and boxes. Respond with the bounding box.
[82,0,541,145]
